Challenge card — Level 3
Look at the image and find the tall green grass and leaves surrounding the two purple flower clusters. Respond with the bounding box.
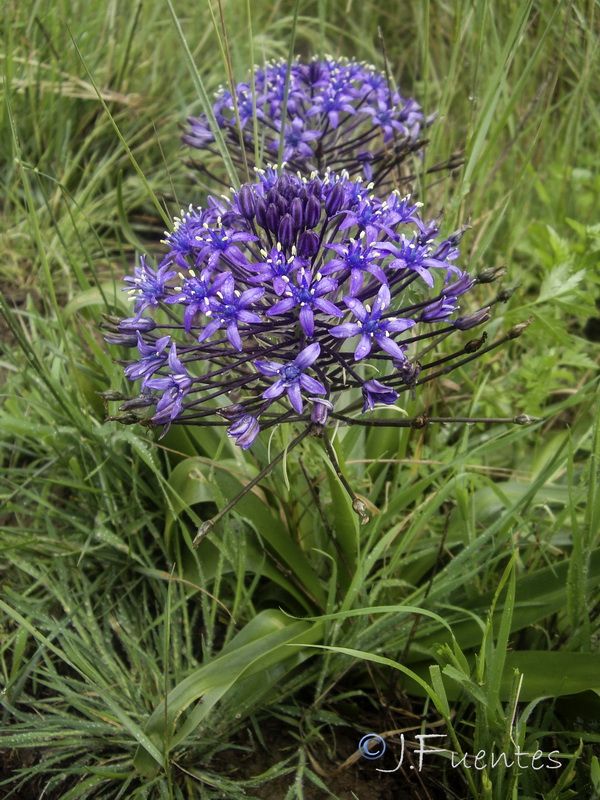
[0,0,600,800]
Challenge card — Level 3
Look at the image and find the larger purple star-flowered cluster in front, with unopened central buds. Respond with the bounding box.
[106,167,489,448]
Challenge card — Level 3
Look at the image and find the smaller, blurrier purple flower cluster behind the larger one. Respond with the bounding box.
[182,58,432,186]
